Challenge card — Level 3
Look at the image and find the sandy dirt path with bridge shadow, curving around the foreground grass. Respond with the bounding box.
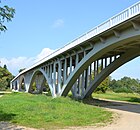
[0,95,140,130]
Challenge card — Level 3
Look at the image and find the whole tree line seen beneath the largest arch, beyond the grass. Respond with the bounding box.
[95,76,140,94]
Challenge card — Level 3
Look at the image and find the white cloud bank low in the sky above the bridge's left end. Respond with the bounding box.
[0,48,54,75]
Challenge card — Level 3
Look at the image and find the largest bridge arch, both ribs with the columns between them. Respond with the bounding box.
[60,33,140,99]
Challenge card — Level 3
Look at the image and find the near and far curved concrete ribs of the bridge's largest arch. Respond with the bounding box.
[61,31,140,98]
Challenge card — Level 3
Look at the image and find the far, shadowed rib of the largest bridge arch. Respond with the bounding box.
[82,48,140,98]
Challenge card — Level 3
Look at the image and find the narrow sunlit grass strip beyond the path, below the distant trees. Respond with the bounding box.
[92,92,140,103]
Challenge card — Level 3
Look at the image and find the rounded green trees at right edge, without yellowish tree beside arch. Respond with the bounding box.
[109,77,140,93]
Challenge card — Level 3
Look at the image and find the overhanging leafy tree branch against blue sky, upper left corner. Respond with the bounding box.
[0,1,15,31]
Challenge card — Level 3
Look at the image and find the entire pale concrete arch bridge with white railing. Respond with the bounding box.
[11,1,140,99]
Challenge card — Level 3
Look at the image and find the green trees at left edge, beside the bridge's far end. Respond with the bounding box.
[0,65,13,90]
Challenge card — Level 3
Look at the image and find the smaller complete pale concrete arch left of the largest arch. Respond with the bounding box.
[29,68,53,95]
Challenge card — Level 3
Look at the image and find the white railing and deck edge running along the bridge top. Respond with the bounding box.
[11,1,140,79]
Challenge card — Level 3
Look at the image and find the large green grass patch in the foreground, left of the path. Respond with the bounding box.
[0,93,112,129]
